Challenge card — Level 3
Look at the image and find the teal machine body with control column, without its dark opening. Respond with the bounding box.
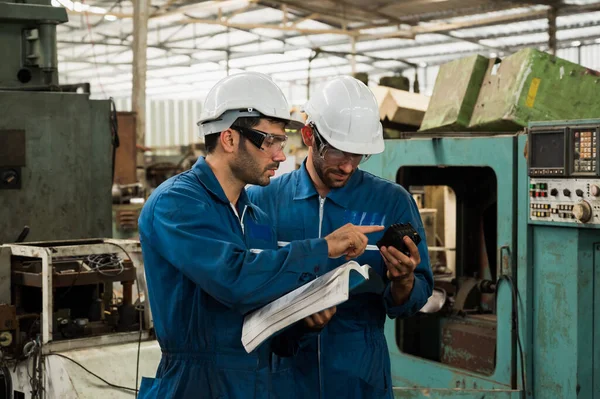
[364,120,600,399]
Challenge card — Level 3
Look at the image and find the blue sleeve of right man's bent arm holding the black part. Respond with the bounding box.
[383,195,433,319]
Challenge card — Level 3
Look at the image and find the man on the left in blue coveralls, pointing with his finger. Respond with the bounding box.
[138,73,382,399]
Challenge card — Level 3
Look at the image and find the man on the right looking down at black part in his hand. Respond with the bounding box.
[248,76,433,399]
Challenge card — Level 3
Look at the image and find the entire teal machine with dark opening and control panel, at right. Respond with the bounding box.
[365,120,600,399]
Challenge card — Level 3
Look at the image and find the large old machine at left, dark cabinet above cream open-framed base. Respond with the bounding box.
[0,0,160,399]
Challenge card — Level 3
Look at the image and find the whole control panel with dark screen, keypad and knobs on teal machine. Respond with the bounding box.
[527,119,600,225]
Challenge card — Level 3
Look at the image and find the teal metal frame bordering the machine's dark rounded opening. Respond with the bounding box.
[364,133,527,399]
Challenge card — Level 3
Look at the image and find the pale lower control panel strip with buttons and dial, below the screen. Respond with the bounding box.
[529,178,600,225]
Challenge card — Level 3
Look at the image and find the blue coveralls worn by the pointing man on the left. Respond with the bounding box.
[138,158,328,399]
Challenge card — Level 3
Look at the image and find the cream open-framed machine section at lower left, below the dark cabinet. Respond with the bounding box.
[0,239,160,398]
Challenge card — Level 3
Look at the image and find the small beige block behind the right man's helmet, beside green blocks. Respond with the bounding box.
[373,86,429,127]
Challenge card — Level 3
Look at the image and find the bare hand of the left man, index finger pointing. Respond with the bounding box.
[325,223,384,260]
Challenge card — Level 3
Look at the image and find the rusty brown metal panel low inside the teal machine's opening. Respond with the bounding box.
[441,315,496,375]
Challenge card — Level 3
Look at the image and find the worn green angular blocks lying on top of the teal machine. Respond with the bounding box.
[421,49,600,131]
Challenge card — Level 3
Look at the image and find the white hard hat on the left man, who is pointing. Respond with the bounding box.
[198,72,304,137]
